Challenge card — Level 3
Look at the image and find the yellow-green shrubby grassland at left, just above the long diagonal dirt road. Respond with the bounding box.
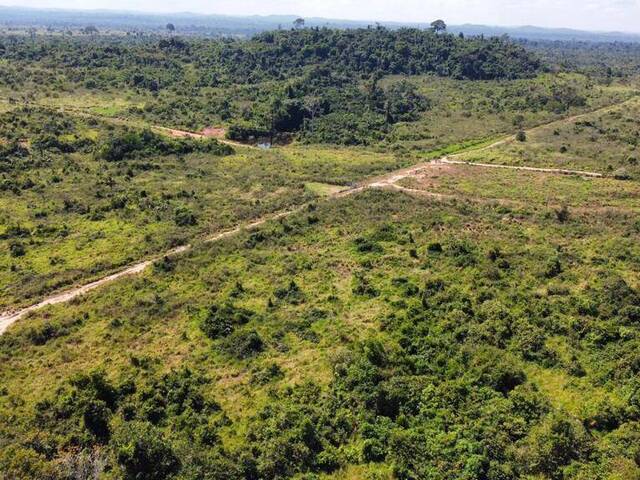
[0,111,411,308]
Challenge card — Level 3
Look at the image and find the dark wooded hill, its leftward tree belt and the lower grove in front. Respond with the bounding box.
[0,28,541,144]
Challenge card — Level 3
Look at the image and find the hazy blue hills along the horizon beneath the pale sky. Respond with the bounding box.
[0,6,640,42]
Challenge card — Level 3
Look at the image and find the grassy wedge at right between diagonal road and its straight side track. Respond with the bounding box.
[462,98,640,179]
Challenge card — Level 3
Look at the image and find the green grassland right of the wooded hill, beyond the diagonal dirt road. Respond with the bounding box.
[385,74,637,151]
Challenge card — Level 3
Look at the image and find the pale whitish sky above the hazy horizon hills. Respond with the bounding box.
[7,0,640,33]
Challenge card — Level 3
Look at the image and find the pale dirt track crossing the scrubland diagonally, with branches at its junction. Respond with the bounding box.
[0,101,627,335]
